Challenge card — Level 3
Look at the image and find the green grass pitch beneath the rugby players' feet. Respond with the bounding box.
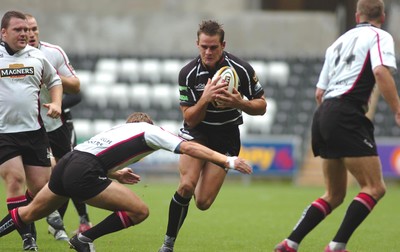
[0,177,400,252]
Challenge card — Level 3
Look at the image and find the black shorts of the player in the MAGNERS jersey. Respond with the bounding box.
[0,127,50,167]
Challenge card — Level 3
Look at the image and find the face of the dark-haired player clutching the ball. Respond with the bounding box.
[197,33,225,68]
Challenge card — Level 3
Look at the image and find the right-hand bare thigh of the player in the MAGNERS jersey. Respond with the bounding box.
[25,165,51,195]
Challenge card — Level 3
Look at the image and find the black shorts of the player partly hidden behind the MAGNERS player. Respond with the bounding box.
[47,123,72,159]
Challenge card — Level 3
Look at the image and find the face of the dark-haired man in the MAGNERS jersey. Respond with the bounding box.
[1,17,28,51]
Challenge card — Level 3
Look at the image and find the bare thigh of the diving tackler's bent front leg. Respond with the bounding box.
[85,181,147,214]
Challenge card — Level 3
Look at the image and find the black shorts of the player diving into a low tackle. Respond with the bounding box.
[49,150,111,201]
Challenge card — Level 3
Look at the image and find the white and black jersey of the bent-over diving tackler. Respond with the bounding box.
[74,122,183,173]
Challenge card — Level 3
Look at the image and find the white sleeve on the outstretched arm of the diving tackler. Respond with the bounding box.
[144,125,183,153]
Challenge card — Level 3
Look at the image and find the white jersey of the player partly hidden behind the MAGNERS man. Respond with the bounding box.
[38,41,76,132]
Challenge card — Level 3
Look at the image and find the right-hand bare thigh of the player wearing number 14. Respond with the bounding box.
[345,156,385,199]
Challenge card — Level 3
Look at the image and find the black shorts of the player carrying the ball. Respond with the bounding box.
[181,125,241,156]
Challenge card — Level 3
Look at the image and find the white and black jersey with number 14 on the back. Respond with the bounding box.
[317,23,397,105]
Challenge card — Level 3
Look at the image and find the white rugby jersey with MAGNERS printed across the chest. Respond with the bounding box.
[0,42,61,133]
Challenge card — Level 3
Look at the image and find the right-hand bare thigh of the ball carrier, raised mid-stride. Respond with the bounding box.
[195,162,226,209]
